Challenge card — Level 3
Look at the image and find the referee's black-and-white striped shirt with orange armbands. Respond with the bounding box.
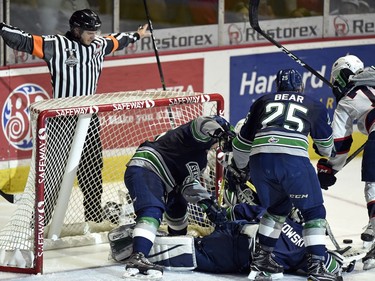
[0,24,139,98]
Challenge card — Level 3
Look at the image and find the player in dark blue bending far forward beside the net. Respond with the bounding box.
[124,116,235,279]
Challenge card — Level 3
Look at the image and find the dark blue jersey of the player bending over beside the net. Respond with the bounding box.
[128,117,220,192]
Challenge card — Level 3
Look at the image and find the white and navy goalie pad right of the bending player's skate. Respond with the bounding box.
[148,236,197,270]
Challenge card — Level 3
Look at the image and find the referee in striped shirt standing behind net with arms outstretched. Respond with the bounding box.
[0,9,148,225]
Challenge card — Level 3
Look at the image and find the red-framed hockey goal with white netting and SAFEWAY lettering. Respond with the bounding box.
[0,91,224,274]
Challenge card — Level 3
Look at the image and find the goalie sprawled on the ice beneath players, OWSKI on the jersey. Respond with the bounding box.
[109,203,355,280]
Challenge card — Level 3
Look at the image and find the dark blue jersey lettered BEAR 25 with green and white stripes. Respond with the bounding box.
[233,92,333,168]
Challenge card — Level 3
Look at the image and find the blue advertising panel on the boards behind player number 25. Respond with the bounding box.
[230,45,375,124]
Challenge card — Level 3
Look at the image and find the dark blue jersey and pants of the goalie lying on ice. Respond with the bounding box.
[195,204,338,273]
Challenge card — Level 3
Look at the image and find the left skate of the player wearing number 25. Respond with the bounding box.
[247,244,284,281]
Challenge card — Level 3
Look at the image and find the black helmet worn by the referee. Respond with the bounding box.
[69,9,102,31]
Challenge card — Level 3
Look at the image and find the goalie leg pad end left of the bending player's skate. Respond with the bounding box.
[108,223,135,261]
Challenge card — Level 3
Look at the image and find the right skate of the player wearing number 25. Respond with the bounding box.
[307,255,343,281]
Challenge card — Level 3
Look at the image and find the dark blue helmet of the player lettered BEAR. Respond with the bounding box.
[276,69,304,93]
